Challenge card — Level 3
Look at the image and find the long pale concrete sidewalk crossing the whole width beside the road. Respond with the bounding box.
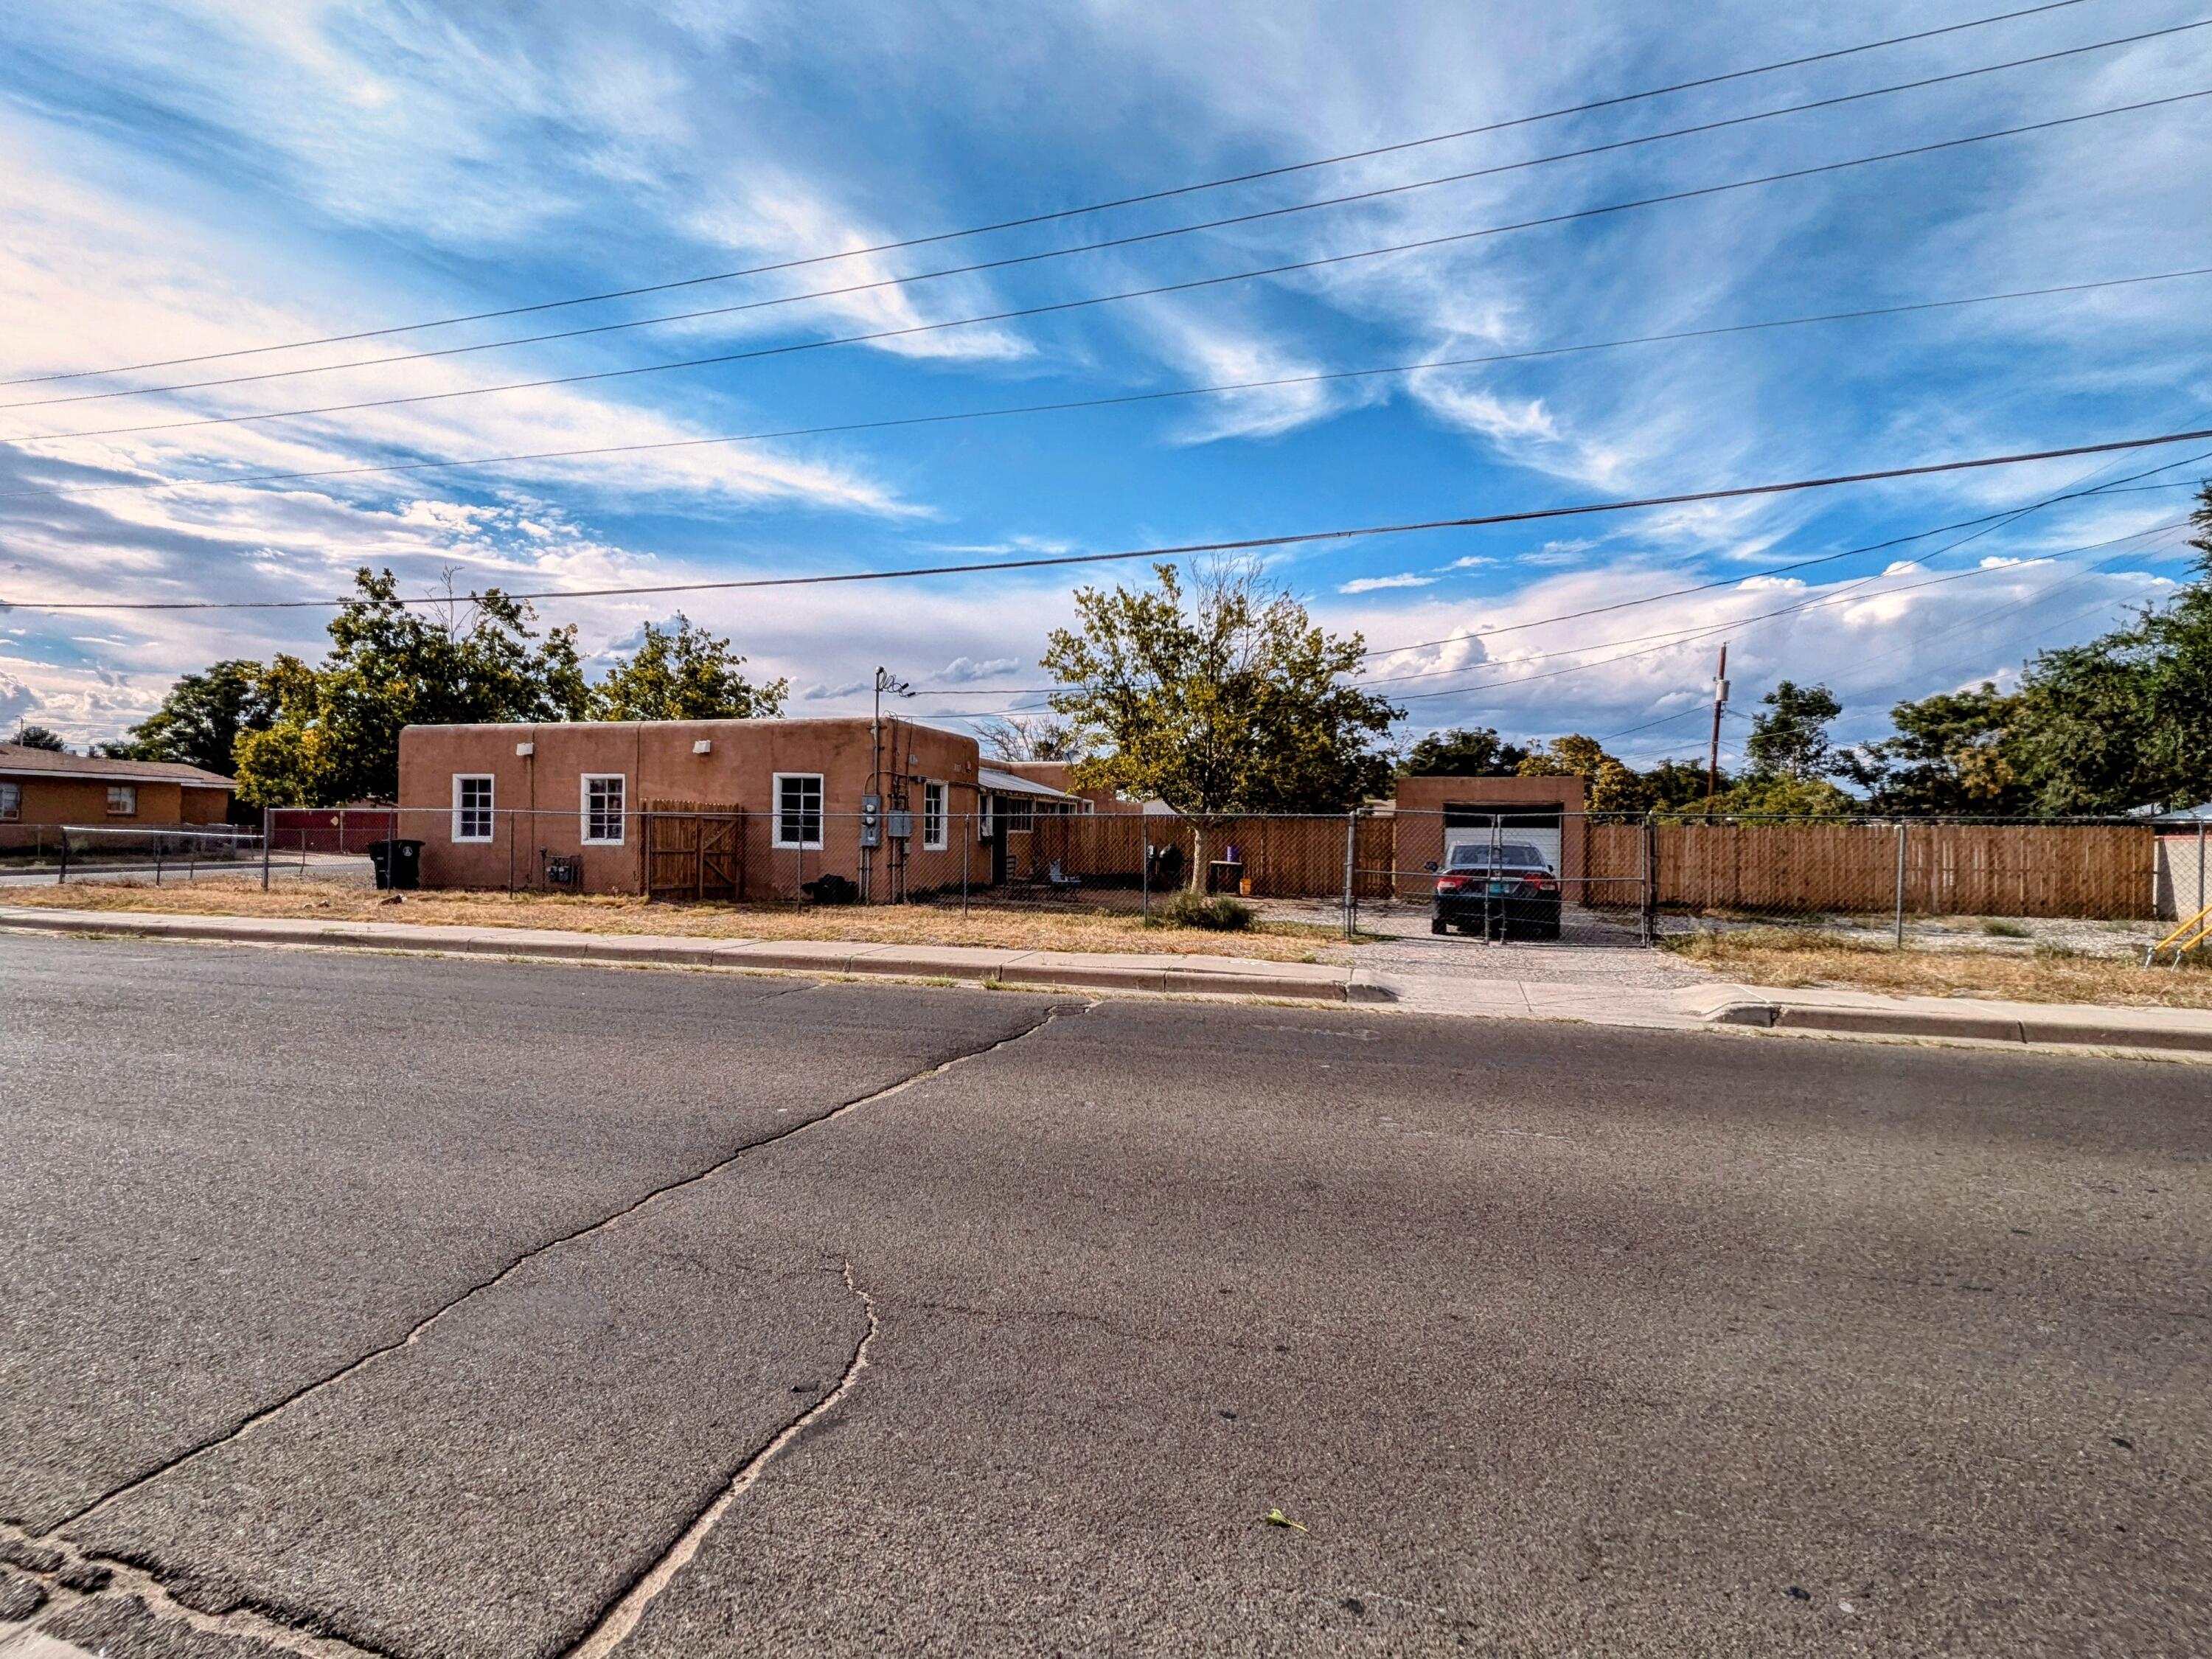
[0,905,2212,1055]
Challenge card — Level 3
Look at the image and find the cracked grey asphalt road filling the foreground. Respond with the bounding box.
[0,936,2212,1659]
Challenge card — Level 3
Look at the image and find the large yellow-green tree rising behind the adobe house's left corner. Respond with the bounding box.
[232,568,588,805]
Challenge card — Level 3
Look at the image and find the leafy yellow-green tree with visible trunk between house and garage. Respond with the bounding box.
[1044,562,1402,885]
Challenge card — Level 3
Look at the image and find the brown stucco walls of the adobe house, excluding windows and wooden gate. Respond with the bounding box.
[400,719,989,898]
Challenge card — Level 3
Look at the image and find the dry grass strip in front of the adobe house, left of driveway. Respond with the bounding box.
[0,878,1343,962]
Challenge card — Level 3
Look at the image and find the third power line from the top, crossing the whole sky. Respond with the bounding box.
[21,86,2212,442]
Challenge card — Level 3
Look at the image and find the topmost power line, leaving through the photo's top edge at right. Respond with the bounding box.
[0,0,2081,385]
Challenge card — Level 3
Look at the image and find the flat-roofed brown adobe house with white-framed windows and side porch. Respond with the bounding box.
[398,719,1084,900]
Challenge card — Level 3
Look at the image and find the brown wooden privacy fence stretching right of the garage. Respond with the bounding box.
[1588,821,2157,920]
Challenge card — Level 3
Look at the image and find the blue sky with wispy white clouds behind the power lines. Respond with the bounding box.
[0,0,2212,761]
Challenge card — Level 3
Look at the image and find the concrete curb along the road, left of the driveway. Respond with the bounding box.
[0,907,1391,1002]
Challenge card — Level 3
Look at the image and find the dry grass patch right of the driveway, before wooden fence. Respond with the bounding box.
[1666,927,2212,1009]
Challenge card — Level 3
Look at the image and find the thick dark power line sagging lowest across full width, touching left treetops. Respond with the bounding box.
[17,427,2212,619]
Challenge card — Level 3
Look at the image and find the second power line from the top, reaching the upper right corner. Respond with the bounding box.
[26,18,2212,409]
